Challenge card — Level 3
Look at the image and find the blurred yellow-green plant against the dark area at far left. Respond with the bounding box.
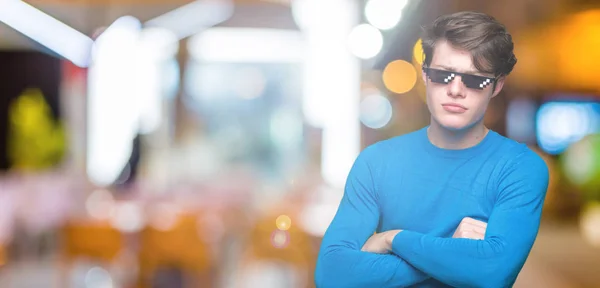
[8,88,66,171]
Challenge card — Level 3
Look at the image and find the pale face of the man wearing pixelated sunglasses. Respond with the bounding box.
[423,41,504,131]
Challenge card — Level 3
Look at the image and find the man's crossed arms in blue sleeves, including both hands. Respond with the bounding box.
[315,148,548,288]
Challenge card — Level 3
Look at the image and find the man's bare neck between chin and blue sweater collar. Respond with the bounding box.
[427,119,489,150]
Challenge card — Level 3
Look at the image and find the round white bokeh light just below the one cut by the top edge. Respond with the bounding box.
[348,24,383,59]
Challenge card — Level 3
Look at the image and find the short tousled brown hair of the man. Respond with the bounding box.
[422,11,517,76]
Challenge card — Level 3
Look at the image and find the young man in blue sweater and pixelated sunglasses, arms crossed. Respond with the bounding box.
[315,12,549,288]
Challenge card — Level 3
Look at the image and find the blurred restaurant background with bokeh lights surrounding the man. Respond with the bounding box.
[0,0,600,288]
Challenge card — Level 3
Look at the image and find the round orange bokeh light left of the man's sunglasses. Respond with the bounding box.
[383,60,417,94]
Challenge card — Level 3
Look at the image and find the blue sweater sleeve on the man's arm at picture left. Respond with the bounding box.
[315,146,429,288]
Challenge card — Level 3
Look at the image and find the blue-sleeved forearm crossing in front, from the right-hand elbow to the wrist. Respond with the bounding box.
[392,231,527,287]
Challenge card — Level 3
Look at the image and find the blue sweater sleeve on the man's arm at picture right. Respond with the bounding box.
[392,150,549,287]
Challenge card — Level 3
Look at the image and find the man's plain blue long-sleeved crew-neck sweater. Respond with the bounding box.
[315,127,549,288]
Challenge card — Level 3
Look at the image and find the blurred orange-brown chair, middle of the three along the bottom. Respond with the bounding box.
[138,213,216,287]
